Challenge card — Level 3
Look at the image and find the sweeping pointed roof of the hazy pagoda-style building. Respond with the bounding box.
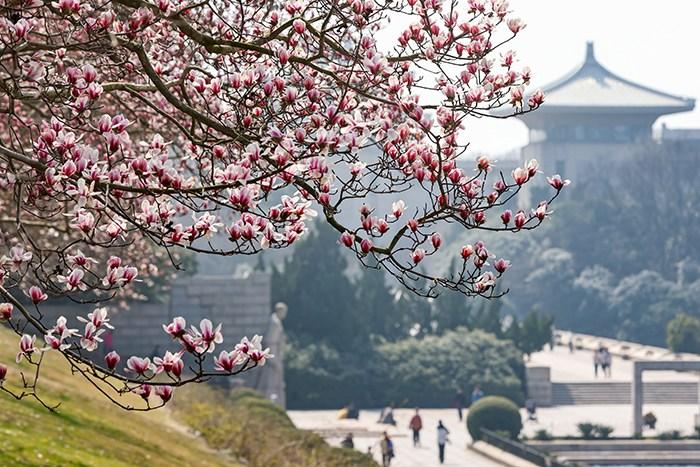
[538,42,695,115]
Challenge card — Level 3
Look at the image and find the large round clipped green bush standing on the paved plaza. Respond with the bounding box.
[467,396,523,440]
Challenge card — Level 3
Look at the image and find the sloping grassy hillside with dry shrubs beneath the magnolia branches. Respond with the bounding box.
[0,327,376,467]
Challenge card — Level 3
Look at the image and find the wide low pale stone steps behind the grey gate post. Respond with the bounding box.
[552,381,698,405]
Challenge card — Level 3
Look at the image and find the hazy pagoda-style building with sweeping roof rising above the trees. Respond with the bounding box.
[518,42,695,191]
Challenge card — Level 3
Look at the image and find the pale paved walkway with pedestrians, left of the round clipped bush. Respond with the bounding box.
[287,409,500,467]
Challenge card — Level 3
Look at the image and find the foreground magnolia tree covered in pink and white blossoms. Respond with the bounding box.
[0,0,567,410]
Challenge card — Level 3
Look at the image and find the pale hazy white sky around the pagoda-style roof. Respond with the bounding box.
[382,0,700,154]
